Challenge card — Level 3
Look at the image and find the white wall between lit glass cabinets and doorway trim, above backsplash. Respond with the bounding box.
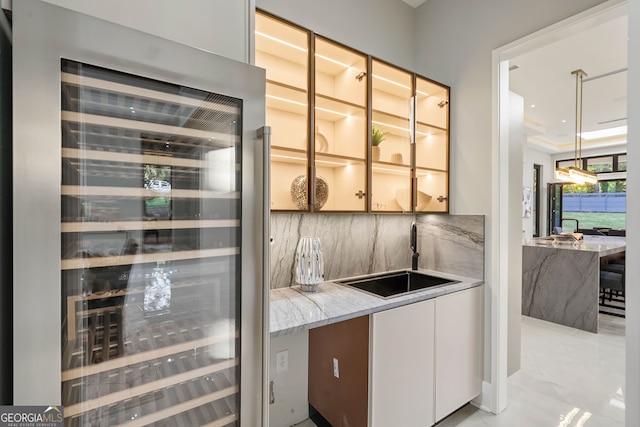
[415,0,603,216]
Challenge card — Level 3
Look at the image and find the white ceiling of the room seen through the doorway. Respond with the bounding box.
[509,15,627,153]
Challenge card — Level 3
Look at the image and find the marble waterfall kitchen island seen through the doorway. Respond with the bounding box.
[522,236,626,333]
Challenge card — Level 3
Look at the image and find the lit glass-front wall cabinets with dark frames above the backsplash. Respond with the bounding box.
[256,11,449,213]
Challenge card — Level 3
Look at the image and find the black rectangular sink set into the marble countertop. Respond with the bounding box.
[334,270,458,298]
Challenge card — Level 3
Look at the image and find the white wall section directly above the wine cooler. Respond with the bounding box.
[40,0,253,62]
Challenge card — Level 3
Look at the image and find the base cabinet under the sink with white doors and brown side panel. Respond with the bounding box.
[309,286,484,427]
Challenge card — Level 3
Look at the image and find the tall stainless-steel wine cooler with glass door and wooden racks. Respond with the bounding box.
[13,0,268,427]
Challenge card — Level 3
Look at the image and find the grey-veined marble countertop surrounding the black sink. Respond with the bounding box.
[270,269,484,337]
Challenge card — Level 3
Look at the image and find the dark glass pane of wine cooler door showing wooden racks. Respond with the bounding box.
[61,60,242,426]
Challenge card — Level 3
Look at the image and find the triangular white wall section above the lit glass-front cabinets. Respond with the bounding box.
[256,0,415,71]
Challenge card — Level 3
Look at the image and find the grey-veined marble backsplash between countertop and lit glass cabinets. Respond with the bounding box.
[270,213,484,288]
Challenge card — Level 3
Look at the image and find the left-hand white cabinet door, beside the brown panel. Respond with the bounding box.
[369,300,435,427]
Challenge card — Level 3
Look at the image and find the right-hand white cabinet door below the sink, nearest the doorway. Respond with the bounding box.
[435,286,484,421]
